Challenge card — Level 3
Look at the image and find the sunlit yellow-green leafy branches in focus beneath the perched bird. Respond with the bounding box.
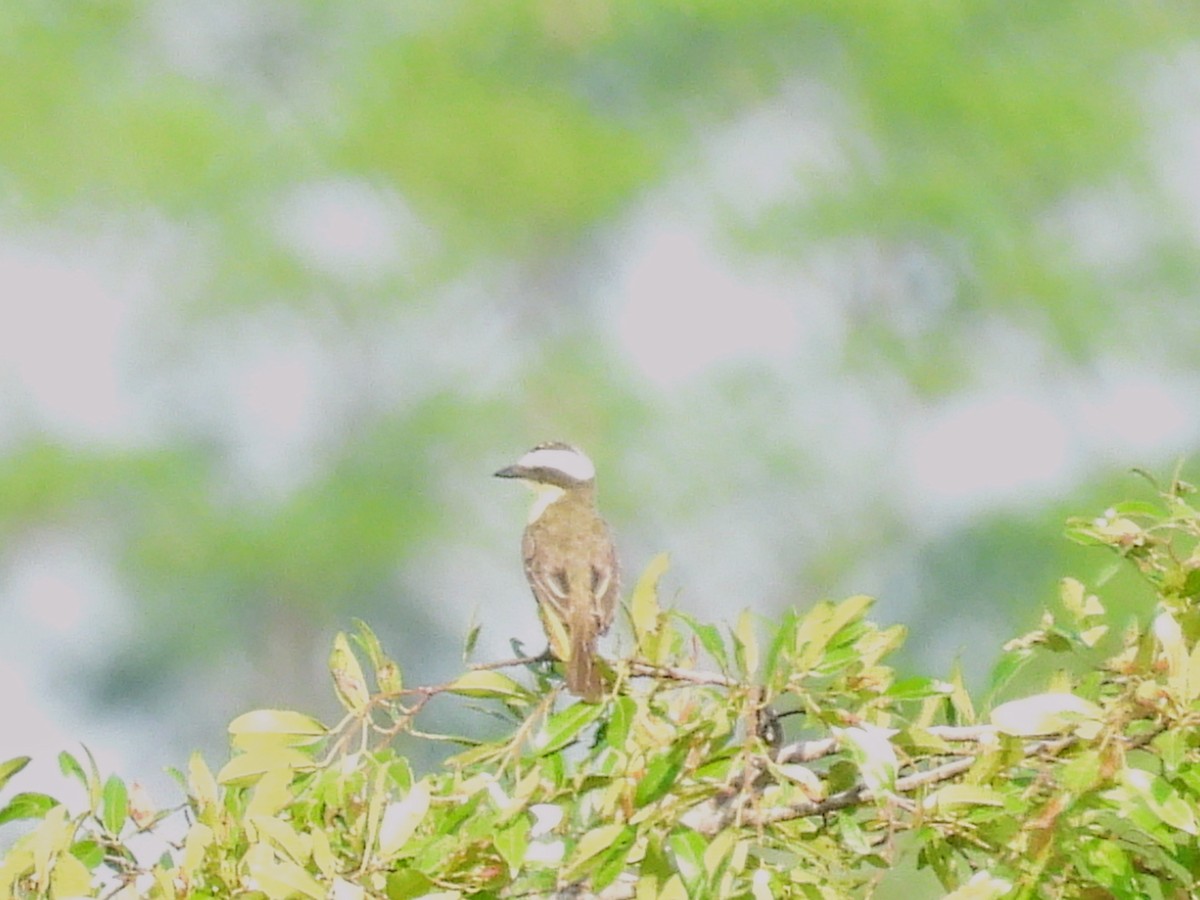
[7,494,1200,900]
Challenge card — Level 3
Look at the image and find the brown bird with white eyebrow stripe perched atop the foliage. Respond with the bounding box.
[496,442,619,703]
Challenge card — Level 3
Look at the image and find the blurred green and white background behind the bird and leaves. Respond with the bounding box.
[0,0,1200,868]
